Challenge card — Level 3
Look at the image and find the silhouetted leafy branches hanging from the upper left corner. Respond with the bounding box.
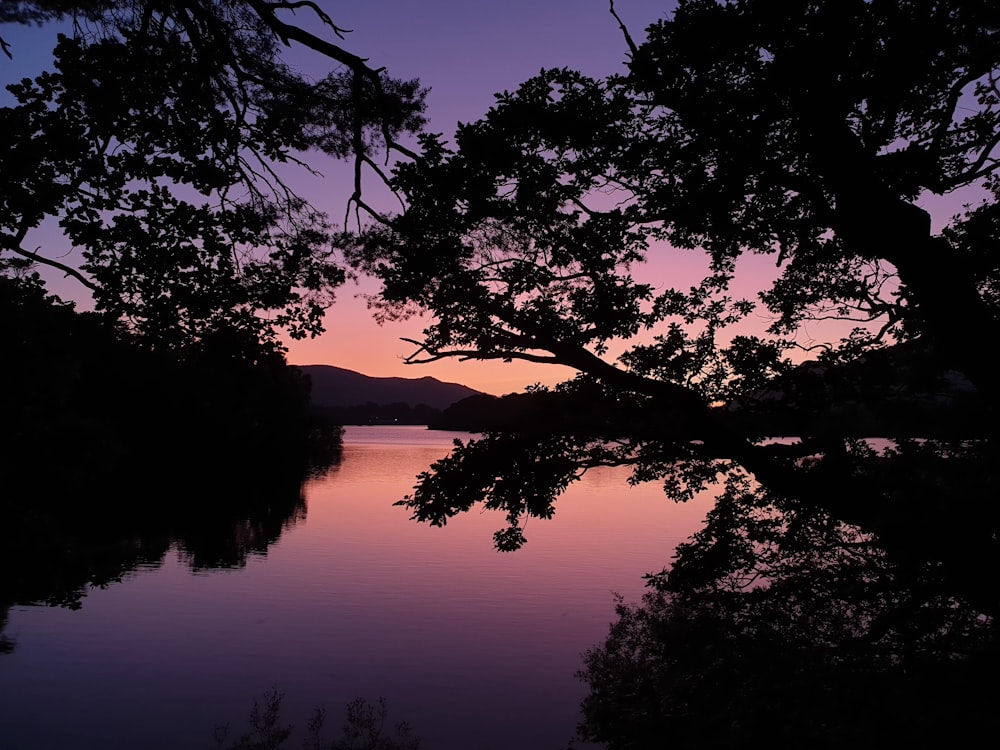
[0,0,424,350]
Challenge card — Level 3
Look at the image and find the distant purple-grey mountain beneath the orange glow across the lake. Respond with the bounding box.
[298,365,479,410]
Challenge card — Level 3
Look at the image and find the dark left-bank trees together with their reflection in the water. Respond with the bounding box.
[0,277,342,648]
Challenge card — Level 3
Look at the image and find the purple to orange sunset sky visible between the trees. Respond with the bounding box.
[0,0,980,394]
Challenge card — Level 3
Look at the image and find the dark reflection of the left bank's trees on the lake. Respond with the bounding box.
[0,451,339,653]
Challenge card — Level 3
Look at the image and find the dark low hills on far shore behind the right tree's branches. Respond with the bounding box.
[427,344,994,439]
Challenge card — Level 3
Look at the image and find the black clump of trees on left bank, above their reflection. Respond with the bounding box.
[0,270,340,506]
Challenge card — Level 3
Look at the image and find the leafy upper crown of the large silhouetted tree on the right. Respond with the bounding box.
[364,0,1000,564]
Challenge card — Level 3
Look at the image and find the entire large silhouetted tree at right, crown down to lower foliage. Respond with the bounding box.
[354,0,1000,747]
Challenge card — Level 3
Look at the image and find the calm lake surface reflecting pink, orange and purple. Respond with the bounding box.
[0,427,708,750]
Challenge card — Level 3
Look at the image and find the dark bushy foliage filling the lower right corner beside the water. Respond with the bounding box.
[581,441,1000,748]
